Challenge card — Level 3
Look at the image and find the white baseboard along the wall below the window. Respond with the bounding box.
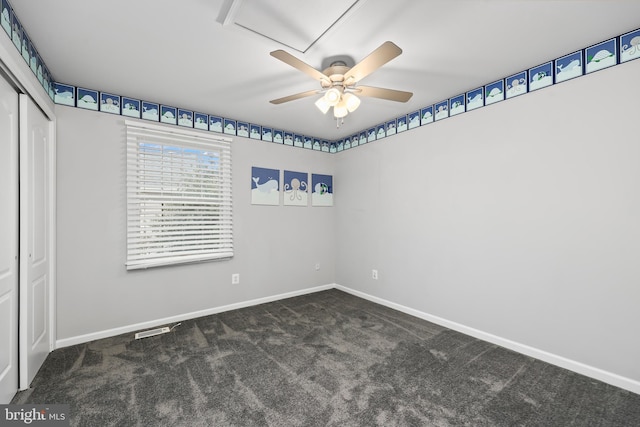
[56,284,335,348]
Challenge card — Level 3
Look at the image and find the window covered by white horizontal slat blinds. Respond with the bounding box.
[125,120,233,270]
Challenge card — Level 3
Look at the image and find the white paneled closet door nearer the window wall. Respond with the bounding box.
[19,95,54,390]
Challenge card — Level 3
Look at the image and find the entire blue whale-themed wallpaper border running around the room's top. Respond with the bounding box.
[0,0,640,153]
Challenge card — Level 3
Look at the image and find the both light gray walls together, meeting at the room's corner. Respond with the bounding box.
[56,61,640,381]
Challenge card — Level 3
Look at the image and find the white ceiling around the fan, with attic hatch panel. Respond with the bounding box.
[11,0,640,140]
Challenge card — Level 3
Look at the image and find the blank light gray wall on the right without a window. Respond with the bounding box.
[335,61,640,381]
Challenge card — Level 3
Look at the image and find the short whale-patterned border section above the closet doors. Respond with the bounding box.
[0,0,55,101]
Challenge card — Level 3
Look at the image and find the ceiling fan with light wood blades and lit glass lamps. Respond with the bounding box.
[269,41,413,126]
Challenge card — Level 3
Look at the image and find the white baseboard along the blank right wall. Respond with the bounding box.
[334,284,640,394]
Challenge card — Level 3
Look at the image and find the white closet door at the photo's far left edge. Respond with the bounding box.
[0,76,19,404]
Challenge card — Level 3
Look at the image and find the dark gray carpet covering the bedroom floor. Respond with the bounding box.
[12,290,640,427]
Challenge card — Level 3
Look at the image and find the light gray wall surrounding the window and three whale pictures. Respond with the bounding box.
[56,106,336,340]
